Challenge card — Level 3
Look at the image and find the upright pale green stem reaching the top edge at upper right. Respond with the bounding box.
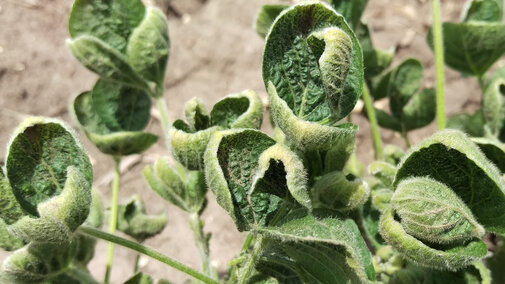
[431,0,445,130]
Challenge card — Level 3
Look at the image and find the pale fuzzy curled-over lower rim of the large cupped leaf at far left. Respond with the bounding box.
[8,166,91,244]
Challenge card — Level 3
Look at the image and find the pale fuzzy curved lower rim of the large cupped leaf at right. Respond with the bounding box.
[379,208,487,271]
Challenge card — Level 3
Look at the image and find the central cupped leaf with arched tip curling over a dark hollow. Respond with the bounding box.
[205,129,310,231]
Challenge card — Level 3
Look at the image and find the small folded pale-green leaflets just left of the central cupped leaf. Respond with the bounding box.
[143,158,207,212]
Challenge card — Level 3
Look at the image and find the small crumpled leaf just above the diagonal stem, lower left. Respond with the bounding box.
[117,195,167,243]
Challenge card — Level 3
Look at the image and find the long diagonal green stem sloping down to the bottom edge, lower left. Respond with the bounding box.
[78,226,219,284]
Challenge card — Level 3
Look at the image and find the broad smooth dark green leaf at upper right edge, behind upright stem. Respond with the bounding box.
[427,21,505,76]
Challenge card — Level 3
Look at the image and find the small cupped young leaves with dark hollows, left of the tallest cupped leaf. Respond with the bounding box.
[170,90,263,170]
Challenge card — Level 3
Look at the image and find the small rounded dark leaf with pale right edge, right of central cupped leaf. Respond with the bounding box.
[311,172,370,212]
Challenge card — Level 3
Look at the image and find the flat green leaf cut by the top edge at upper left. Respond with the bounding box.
[68,0,146,53]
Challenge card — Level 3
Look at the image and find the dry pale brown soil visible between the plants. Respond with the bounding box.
[0,0,480,283]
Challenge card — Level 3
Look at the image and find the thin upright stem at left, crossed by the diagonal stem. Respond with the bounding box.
[104,156,121,284]
